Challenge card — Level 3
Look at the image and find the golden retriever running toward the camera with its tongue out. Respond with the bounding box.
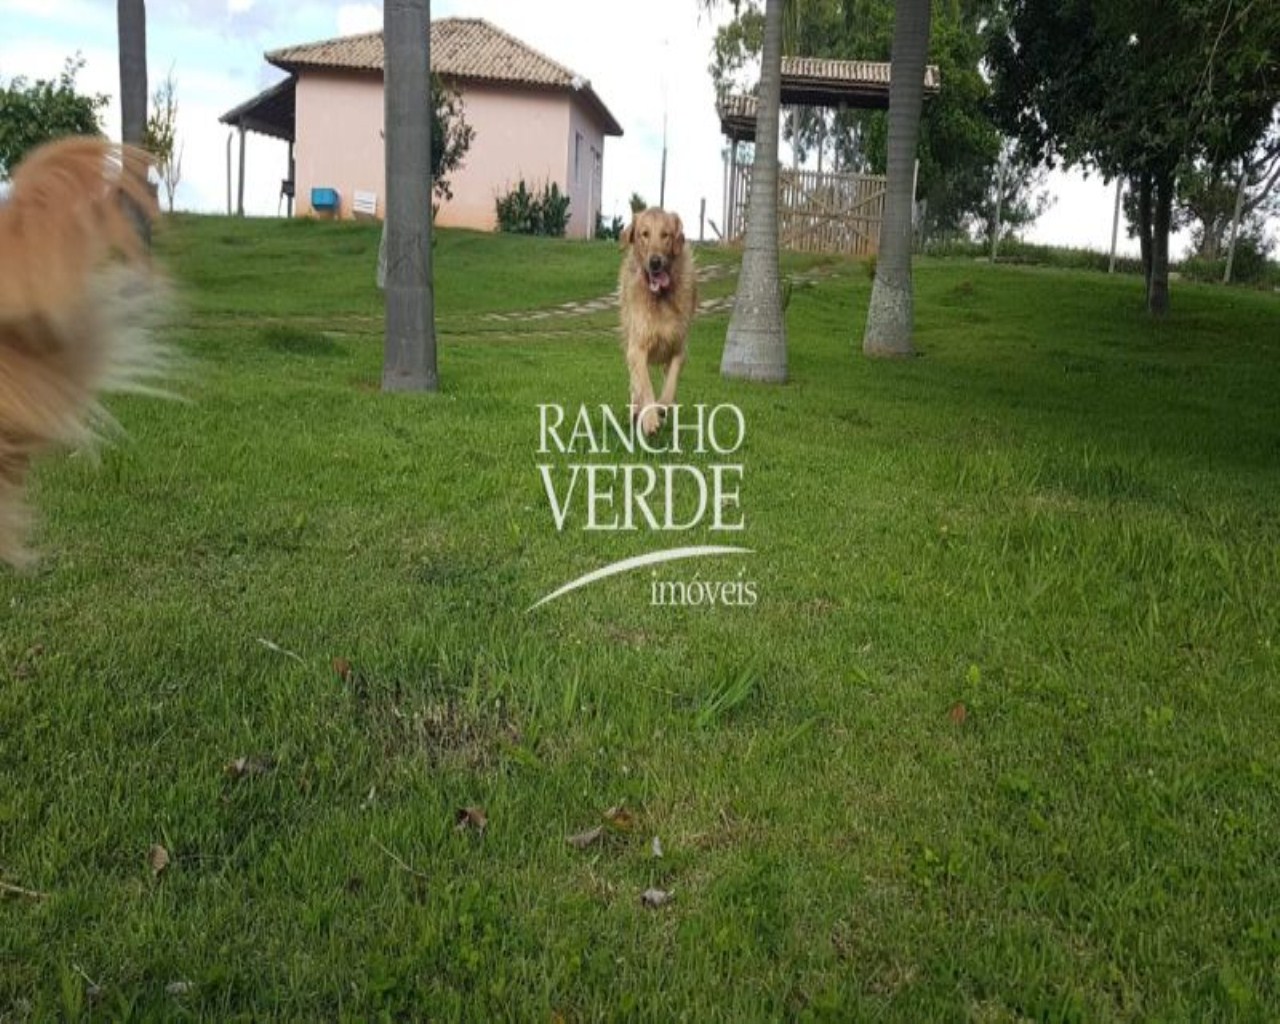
[618,207,698,435]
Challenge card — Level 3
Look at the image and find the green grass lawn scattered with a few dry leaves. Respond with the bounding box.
[0,218,1280,1021]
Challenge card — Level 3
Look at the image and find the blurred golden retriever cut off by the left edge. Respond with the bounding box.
[0,137,165,566]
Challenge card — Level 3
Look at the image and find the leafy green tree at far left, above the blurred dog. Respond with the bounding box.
[0,54,108,180]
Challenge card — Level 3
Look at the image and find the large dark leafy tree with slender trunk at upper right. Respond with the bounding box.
[988,0,1280,316]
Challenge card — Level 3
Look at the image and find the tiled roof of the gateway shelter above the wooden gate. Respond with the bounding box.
[717,56,941,140]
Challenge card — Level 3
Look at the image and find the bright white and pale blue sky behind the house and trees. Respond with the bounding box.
[0,0,1198,252]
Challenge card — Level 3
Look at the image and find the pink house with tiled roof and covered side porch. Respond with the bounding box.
[221,18,622,238]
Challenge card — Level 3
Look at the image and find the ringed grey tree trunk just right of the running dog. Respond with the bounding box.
[721,0,787,381]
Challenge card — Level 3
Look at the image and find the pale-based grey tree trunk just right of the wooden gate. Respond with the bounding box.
[863,0,929,356]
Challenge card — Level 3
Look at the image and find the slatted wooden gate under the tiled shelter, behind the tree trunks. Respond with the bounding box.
[727,164,886,256]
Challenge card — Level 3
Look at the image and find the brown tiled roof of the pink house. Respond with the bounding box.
[266,18,622,136]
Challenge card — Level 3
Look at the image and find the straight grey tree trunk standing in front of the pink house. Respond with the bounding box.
[383,0,439,392]
